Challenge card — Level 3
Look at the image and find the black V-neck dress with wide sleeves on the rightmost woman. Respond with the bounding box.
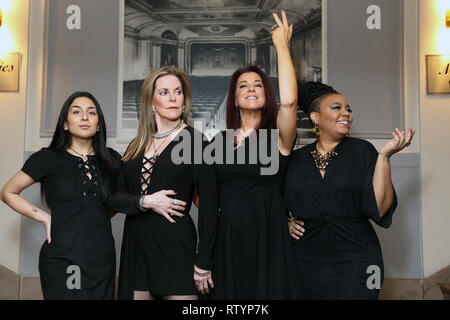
[284,137,397,299]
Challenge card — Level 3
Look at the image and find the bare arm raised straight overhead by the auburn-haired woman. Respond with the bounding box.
[272,10,297,155]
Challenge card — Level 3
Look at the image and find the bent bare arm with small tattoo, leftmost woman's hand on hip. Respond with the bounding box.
[0,171,51,243]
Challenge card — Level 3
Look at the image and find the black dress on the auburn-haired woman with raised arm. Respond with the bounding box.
[210,133,301,300]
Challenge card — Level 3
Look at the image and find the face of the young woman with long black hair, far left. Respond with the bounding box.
[64,97,99,139]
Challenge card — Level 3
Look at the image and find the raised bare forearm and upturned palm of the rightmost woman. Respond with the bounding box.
[373,128,415,218]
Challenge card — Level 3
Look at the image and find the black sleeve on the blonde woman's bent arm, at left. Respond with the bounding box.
[108,159,142,215]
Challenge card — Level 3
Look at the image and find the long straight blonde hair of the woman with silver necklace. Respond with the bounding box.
[122,66,192,162]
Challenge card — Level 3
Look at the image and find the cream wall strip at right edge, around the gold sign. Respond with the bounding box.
[419,0,450,277]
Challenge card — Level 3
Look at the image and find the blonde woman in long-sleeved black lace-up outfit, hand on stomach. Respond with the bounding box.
[109,66,217,300]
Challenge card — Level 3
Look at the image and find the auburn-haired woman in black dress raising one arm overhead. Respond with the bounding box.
[211,10,301,300]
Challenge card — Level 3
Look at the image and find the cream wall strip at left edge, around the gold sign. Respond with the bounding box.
[0,0,29,273]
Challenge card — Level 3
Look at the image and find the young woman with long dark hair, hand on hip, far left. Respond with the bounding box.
[1,92,120,299]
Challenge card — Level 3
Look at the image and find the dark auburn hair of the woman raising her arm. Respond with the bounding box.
[227,66,278,130]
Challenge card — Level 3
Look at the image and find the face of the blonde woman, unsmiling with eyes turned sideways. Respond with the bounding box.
[152,74,184,121]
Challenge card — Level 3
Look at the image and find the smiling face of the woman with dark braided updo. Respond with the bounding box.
[311,94,353,139]
